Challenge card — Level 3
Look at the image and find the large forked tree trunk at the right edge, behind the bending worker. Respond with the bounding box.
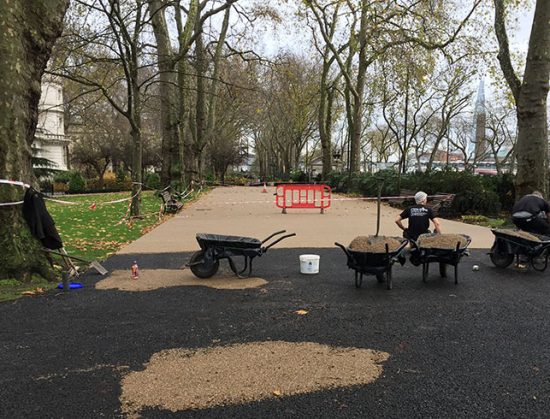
[494,0,550,198]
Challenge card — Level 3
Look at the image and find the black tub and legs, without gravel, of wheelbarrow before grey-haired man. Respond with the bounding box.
[410,233,472,285]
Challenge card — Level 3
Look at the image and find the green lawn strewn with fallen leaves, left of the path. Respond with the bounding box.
[0,191,204,301]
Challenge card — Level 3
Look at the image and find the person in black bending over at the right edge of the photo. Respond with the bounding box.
[512,191,550,236]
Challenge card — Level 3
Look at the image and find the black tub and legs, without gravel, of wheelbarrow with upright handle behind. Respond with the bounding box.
[334,237,409,290]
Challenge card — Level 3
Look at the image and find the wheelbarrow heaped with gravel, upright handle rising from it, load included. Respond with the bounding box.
[334,236,409,290]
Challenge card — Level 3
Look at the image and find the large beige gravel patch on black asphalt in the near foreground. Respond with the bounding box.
[120,341,389,414]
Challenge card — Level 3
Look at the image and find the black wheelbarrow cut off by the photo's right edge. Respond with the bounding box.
[489,229,550,272]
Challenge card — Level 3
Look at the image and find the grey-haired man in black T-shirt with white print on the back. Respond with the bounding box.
[395,191,441,241]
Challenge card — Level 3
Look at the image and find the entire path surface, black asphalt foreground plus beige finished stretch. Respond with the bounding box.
[0,188,550,418]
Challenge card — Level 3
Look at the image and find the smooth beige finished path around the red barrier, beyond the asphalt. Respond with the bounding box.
[119,186,493,254]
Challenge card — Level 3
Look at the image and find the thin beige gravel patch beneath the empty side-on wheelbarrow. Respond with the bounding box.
[95,269,267,291]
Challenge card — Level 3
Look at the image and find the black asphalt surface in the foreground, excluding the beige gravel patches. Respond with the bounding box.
[0,247,550,418]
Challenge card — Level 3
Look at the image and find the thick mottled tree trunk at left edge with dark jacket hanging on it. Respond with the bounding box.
[0,0,68,279]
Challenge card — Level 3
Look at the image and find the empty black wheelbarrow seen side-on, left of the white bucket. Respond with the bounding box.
[186,230,296,278]
